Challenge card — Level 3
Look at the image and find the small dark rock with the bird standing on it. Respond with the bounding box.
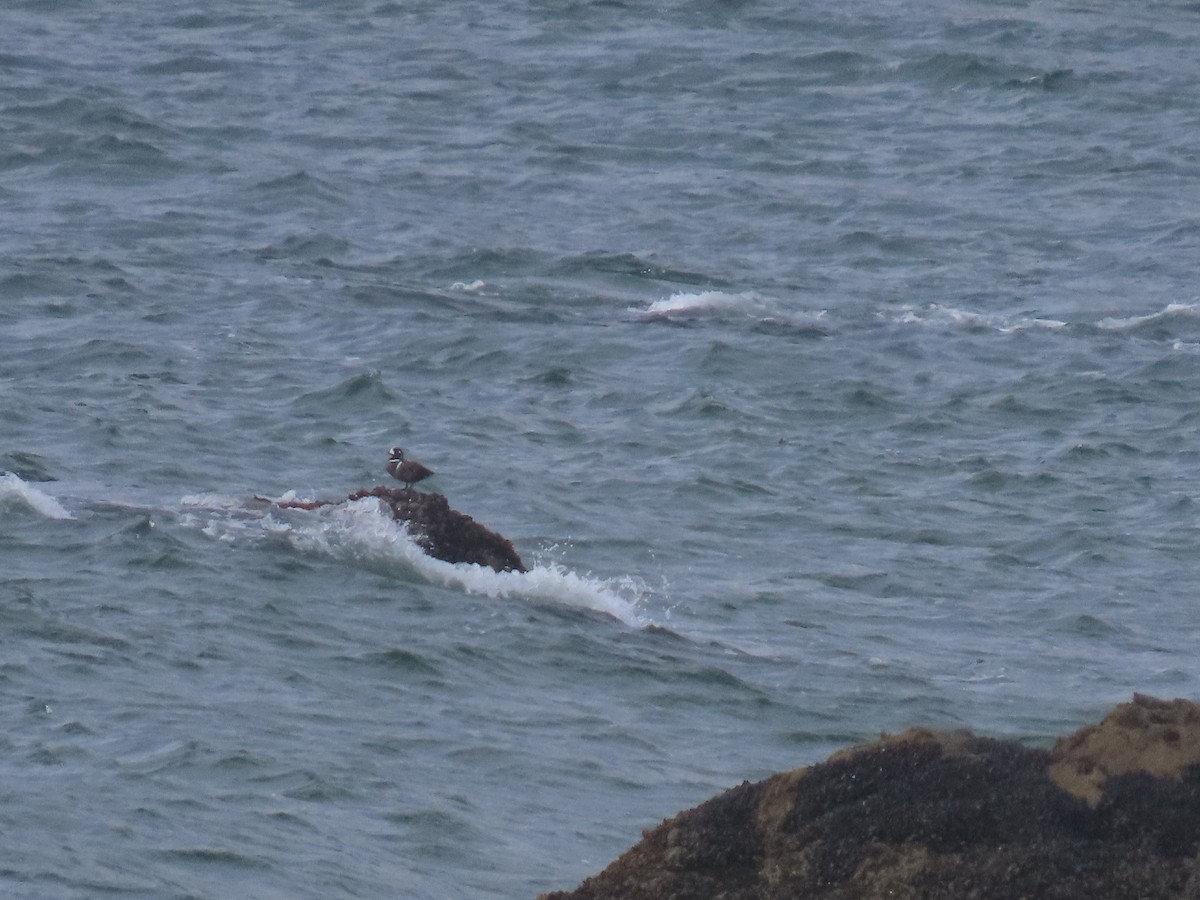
[349,487,528,572]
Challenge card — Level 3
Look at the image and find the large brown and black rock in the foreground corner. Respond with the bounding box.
[542,694,1200,900]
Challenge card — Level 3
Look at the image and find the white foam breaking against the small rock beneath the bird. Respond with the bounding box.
[185,491,650,628]
